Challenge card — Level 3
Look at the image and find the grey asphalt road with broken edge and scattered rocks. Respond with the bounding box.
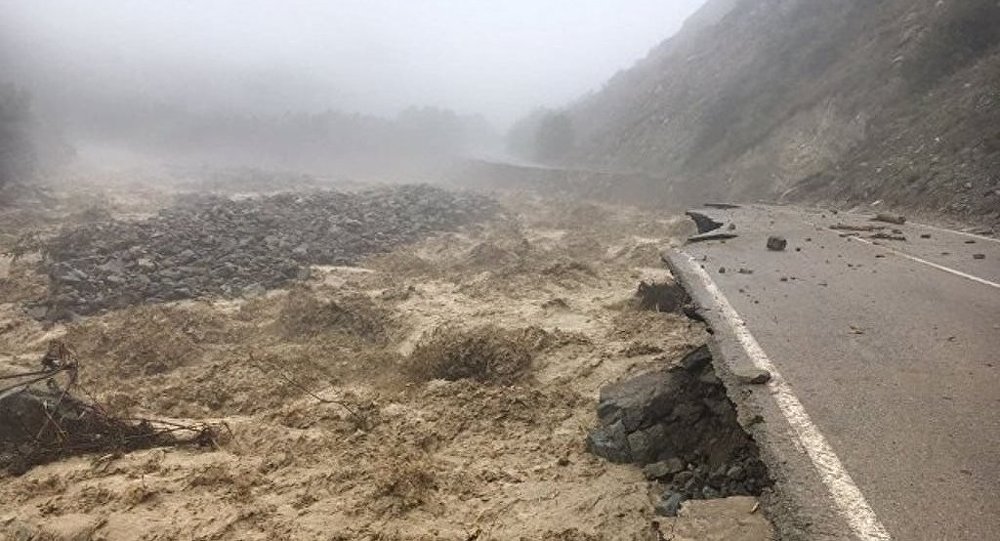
[665,206,1000,541]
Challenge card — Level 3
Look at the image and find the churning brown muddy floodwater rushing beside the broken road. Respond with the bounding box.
[0,175,770,540]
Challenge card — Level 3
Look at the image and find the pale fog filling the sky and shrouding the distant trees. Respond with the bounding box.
[0,0,703,175]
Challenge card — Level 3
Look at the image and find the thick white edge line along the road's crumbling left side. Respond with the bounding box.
[681,252,892,541]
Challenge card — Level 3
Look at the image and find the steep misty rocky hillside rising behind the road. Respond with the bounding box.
[565,0,1000,224]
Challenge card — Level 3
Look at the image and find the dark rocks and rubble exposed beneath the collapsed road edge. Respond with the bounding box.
[587,346,771,516]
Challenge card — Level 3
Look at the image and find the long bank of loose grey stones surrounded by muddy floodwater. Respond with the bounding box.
[37,185,496,320]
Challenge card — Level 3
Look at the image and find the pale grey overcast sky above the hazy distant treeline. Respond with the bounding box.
[0,0,704,127]
